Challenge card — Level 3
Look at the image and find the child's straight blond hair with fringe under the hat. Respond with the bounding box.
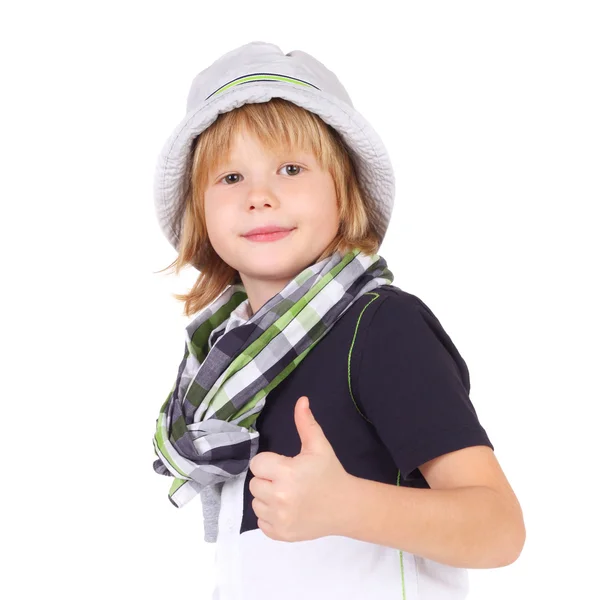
[157,98,383,317]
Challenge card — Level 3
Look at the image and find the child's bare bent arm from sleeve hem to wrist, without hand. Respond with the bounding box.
[332,446,525,568]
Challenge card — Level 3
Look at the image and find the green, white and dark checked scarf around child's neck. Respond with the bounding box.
[153,248,393,542]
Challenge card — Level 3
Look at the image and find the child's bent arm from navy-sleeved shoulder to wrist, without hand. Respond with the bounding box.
[337,292,525,568]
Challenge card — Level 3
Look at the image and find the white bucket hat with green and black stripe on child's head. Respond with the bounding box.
[154,41,395,250]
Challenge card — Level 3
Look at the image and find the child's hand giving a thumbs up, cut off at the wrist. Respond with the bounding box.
[249,396,352,542]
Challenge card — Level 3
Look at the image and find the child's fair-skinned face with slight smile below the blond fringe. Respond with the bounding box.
[204,129,339,289]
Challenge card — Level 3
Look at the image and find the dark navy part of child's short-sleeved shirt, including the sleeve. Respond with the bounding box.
[236,285,494,533]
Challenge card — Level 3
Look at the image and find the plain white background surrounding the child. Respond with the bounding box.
[0,0,600,600]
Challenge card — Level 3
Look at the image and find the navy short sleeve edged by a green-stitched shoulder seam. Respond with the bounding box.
[357,292,494,480]
